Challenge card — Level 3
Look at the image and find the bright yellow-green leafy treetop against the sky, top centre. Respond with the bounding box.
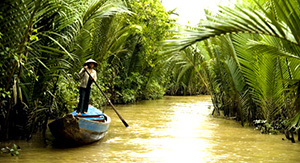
[129,0,174,63]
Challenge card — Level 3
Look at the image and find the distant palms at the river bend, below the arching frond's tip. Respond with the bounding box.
[160,46,207,95]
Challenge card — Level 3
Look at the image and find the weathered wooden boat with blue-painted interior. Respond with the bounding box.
[48,105,111,145]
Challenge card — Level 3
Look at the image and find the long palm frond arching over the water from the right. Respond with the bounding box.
[165,0,300,51]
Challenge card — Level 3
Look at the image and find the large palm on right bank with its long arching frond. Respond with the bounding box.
[166,0,300,131]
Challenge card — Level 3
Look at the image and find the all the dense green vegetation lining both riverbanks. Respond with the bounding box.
[0,0,300,143]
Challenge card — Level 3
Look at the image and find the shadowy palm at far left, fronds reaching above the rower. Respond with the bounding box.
[0,0,128,140]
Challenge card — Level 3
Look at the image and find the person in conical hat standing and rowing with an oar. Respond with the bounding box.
[77,59,98,115]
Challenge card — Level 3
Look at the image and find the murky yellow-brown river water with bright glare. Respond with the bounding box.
[0,96,300,163]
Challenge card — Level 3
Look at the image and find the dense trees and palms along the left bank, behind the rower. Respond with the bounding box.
[0,0,175,139]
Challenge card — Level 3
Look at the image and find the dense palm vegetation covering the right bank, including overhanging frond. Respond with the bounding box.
[166,0,300,141]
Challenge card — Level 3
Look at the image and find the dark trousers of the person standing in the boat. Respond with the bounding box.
[77,87,91,113]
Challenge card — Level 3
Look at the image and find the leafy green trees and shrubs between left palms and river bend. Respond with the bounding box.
[93,0,174,103]
